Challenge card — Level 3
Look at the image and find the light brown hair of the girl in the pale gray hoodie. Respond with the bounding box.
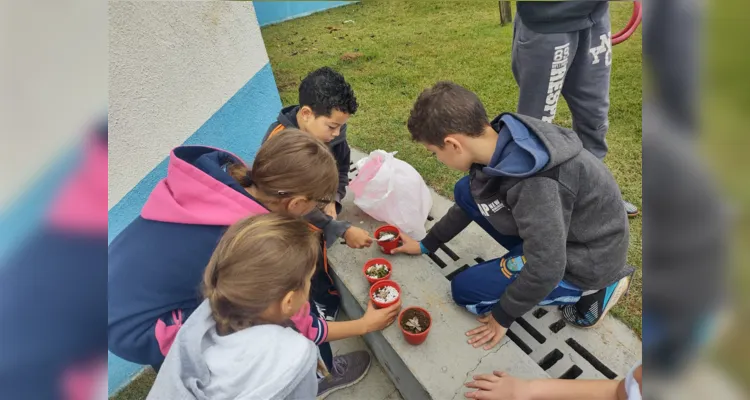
[203,213,320,335]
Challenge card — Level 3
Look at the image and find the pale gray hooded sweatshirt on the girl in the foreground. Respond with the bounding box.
[147,300,318,400]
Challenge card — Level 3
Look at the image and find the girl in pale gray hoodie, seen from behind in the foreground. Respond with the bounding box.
[148,214,320,399]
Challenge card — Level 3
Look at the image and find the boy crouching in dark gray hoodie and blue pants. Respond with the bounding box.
[394,82,633,349]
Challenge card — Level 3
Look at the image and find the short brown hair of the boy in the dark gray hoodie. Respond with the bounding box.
[407,81,489,148]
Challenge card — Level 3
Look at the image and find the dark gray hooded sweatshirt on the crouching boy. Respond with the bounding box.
[422,113,633,327]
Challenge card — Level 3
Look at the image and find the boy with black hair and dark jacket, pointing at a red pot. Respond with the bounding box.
[263,67,373,249]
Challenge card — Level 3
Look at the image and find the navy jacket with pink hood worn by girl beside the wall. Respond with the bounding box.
[108,146,328,367]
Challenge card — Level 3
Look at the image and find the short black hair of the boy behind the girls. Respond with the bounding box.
[299,67,357,117]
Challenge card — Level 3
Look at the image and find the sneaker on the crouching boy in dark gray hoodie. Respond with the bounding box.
[561,276,630,328]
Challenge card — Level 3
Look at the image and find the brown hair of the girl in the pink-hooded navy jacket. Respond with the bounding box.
[227,128,339,201]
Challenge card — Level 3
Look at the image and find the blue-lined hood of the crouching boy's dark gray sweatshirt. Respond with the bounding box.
[482,113,583,178]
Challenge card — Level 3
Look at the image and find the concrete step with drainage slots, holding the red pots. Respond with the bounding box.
[328,150,641,400]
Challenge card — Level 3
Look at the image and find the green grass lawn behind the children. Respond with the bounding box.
[262,0,642,335]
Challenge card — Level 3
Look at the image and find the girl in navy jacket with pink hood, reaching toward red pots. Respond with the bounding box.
[108,129,398,396]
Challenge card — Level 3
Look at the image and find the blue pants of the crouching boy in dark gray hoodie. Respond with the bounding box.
[451,176,582,315]
